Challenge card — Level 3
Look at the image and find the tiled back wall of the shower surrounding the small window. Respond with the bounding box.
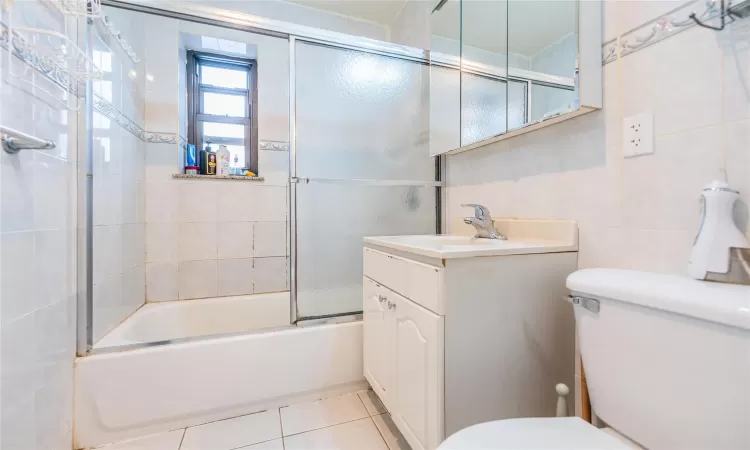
[145,16,289,301]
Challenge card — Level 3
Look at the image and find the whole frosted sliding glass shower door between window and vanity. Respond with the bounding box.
[291,41,438,319]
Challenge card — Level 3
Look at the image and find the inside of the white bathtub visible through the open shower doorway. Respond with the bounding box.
[94,292,289,349]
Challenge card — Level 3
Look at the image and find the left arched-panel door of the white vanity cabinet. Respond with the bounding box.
[362,277,392,410]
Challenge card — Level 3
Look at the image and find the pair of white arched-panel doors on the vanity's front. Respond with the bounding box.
[363,260,444,450]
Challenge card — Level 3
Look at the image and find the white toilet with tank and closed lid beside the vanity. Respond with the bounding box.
[438,269,750,450]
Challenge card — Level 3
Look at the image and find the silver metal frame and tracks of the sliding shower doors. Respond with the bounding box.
[81,0,445,356]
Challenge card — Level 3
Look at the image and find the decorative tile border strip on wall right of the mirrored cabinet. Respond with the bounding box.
[602,0,721,65]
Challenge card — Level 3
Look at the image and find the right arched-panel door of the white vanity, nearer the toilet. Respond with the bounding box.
[386,295,443,450]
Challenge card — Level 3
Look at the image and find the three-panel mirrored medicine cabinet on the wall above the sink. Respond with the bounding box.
[429,0,601,155]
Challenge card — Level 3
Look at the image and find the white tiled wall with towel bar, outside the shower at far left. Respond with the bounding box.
[0,2,78,450]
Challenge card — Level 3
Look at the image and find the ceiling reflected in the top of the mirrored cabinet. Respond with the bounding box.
[431,0,576,56]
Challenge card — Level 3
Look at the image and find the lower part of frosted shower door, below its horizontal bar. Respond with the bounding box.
[297,181,435,318]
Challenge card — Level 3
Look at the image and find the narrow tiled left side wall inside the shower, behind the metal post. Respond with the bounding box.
[93,8,148,341]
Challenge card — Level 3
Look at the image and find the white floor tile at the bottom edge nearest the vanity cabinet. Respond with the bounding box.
[284,417,388,450]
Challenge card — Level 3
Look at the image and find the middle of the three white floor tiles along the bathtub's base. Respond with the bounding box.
[180,409,281,450]
